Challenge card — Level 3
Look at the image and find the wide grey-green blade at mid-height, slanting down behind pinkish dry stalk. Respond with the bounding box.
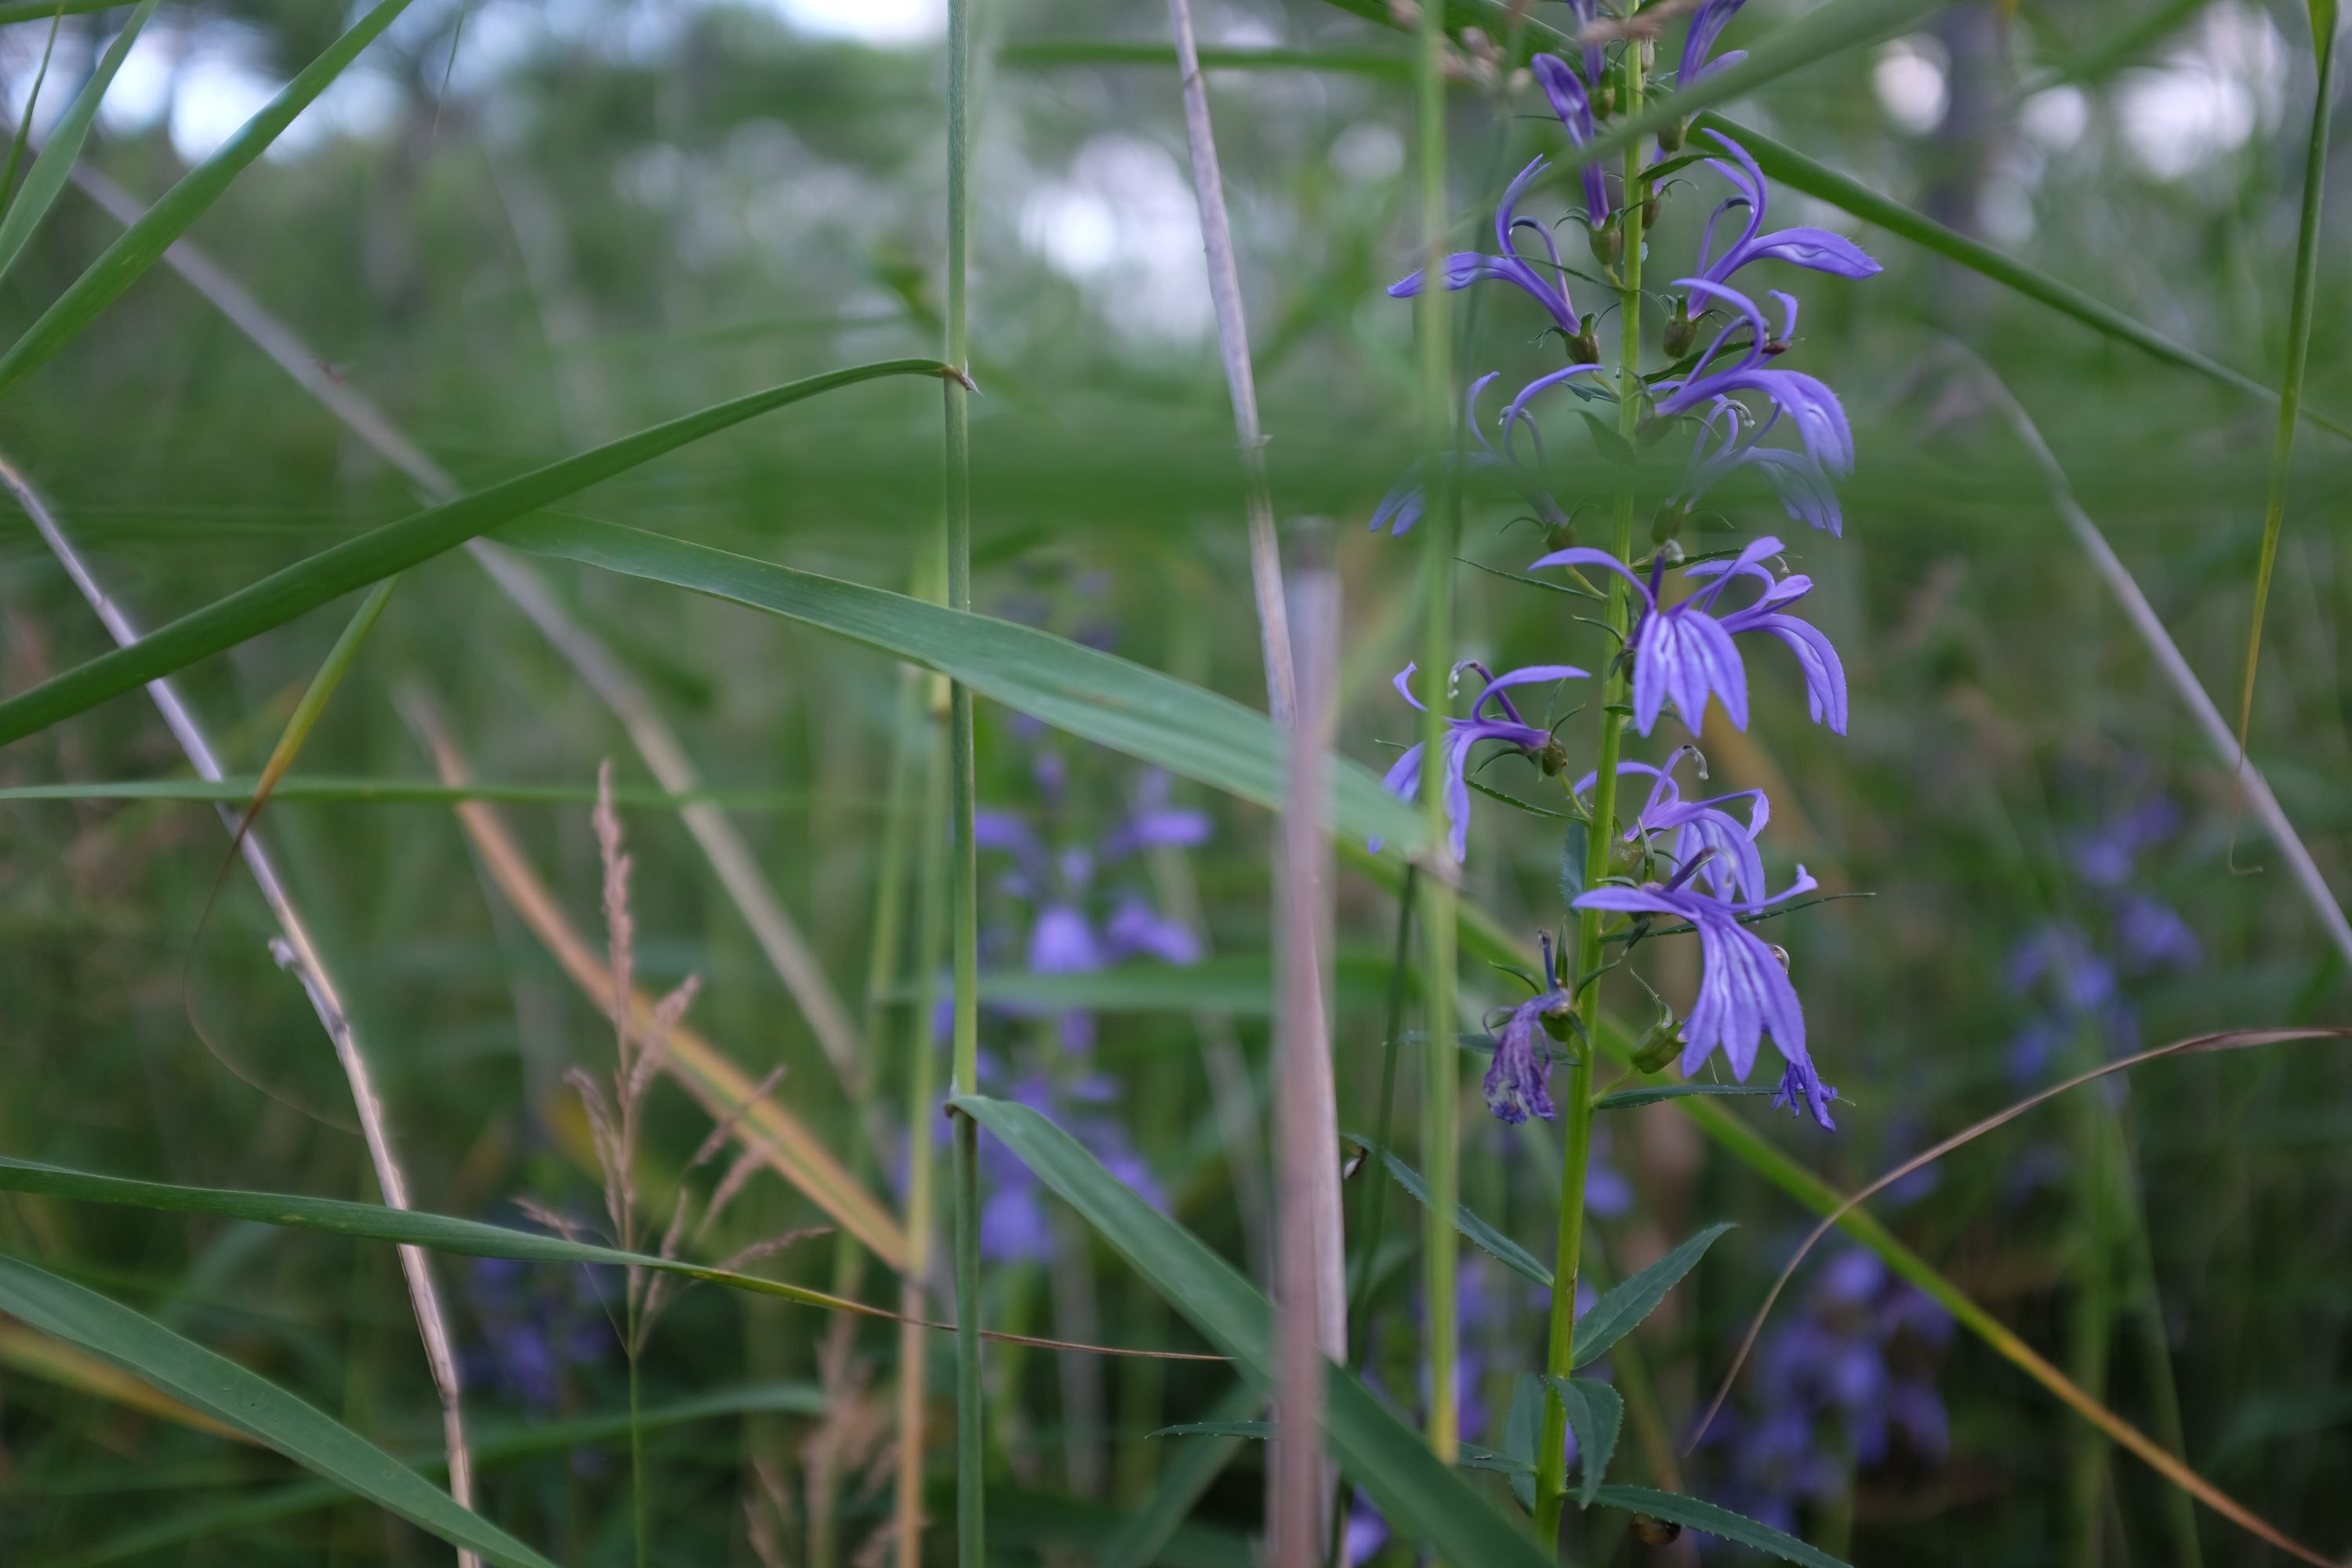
[503,517,1421,851]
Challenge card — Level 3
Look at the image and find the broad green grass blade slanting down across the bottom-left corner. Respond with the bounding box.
[0,1258,555,1568]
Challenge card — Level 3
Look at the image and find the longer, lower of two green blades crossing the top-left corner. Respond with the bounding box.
[0,0,423,395]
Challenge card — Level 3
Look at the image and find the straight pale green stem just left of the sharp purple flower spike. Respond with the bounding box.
[1414,5,1461,1465]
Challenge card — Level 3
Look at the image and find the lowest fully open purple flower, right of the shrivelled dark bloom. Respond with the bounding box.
[1576,865,1820,1079]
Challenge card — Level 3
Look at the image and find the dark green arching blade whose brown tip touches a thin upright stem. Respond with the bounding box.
[0,360,950,746]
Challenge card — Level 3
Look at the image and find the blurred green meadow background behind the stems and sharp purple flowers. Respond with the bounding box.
[0,0,2352,1566]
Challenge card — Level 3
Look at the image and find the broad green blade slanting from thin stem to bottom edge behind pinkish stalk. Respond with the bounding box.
[953,1095,1550,1568]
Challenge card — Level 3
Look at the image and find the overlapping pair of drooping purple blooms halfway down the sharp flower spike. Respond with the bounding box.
[1529,536,1846,736]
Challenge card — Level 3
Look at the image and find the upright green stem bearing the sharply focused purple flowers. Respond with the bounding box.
[1534,47,1644,1549]
